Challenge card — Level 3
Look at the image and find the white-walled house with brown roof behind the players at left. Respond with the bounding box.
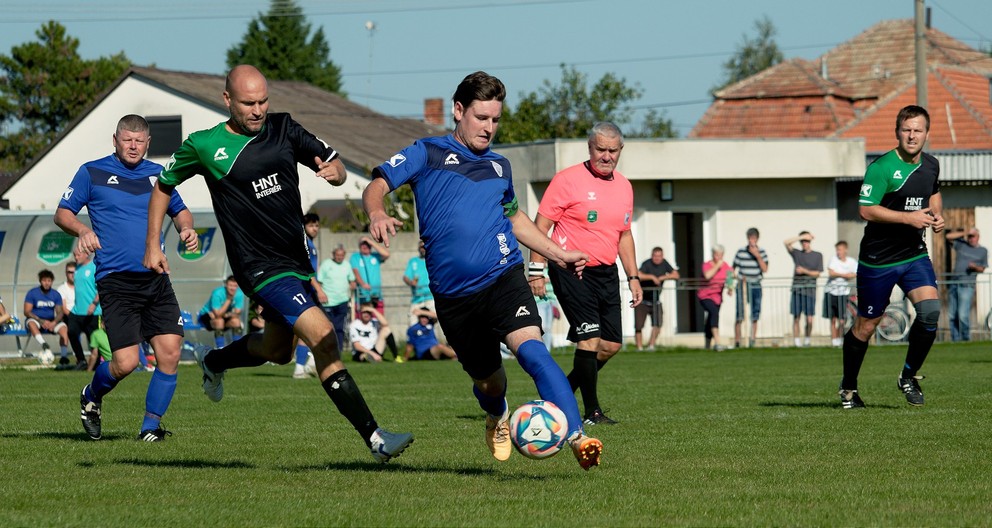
[0,67,445,211]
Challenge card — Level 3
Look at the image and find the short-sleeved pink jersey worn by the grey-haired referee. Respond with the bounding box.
[537,162,634,266]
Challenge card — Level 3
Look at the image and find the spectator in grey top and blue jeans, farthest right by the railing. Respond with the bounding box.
[947,227,989,341]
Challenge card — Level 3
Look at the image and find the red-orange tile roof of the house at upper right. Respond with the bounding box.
[689,20,992,152]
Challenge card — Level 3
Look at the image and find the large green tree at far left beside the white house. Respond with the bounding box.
[0,21,131,172]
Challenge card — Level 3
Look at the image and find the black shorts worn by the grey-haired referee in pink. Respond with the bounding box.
[548,264,623,343]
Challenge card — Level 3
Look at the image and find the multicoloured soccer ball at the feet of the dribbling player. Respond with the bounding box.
[510,400,568,459]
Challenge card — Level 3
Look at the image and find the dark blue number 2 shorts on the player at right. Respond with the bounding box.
[858,257,937,319]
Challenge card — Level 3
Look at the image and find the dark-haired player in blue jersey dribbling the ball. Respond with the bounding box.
[362,72,603,469]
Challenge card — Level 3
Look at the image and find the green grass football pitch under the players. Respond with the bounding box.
[0,342,992,528]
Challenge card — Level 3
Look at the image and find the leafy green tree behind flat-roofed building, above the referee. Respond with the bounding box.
[496,64,675,143]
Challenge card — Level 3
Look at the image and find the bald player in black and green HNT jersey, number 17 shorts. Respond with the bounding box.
[145,65,413,462]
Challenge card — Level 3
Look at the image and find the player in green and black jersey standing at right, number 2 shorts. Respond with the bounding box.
[840,105,944,409]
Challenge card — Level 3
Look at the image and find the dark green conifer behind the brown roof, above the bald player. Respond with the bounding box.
[227,0,344,95]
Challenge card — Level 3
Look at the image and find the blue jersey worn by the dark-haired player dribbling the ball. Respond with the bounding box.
[372,135,523,297]
